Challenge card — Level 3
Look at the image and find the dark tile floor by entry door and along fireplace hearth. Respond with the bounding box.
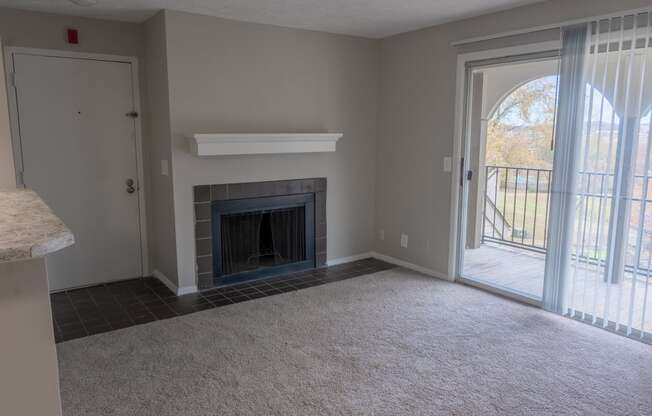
[51,259,395,342]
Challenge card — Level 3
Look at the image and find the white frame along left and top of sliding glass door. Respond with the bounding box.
[448,40,561,290]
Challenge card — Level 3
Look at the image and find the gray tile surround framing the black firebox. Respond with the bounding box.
[193,178,326,290]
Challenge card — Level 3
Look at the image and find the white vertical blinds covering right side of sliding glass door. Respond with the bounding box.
[544,13,652,337]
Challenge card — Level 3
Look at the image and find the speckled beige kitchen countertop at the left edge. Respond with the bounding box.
[0,189,75,262]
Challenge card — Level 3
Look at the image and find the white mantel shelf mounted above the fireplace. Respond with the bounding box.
[190,133,342,156]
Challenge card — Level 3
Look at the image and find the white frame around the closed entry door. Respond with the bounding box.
[5,47,149,276]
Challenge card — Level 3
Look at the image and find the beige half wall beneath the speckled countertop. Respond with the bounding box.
[0,258,61,416]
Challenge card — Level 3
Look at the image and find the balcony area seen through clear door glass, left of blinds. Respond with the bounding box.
[464,166,552,299]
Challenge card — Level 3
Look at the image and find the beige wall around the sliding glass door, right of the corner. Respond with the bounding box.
[375,0,652,275]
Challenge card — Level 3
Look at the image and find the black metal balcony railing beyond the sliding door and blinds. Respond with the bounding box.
[482,166,652,269]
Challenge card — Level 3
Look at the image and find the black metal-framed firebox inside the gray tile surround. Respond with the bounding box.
[212,194,315,285]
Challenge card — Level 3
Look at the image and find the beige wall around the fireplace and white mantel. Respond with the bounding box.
[160,12,379,286]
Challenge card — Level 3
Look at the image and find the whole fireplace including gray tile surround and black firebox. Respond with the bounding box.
[193,178,326,289]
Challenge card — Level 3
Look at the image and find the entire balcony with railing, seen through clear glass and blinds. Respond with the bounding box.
[463,166,652,327]
